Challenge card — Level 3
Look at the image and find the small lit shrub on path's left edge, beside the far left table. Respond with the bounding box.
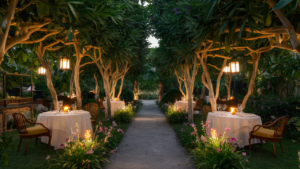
[112,105,135,123]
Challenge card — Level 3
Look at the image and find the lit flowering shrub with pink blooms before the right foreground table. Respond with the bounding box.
[190,122,248,169]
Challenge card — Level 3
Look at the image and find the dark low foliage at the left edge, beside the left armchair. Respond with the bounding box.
[0,132,14,166]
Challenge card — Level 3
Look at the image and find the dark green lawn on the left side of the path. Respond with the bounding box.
[0,110,130,169]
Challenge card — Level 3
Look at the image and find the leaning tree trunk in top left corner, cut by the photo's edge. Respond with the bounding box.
[0,0,18,65]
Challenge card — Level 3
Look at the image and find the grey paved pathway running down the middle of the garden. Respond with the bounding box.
[105,100,195,169]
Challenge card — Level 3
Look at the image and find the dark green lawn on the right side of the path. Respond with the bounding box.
[172,115,300,169]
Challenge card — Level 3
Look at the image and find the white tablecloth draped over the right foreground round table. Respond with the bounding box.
[206,111,262,148]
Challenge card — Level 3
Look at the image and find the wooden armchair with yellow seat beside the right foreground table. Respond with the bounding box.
[249,116,290,157]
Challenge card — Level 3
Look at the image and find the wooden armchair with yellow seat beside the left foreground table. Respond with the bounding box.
[12,113,51,155]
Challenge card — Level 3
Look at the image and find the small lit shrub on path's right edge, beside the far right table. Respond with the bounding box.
[165,106,188,124]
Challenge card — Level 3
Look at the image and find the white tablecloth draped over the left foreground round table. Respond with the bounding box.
[37,110,93,146]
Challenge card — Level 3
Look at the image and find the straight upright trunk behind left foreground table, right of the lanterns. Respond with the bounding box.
[74,43,85,110]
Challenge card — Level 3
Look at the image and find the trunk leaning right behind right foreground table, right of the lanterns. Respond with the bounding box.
[242,53,261,109]
